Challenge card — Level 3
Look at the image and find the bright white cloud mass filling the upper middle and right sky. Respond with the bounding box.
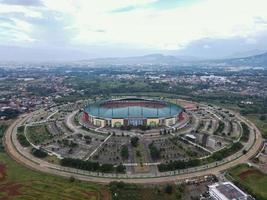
[0,0,267,49]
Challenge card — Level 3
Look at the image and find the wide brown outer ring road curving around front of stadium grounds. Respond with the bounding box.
[4,111,262,184]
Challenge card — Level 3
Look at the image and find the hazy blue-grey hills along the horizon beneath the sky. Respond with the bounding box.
[76,52,267,69]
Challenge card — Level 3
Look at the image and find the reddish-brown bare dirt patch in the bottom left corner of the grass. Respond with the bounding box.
[0,183,22,200]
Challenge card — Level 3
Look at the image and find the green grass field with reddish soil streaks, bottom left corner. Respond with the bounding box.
[0,153,109,200]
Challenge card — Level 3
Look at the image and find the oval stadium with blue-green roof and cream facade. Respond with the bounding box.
[82,98,183,128]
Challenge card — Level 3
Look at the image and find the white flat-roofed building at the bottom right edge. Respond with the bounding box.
[208,182,251,200]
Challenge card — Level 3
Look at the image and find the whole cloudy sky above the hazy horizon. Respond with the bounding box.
[0,0,267,61]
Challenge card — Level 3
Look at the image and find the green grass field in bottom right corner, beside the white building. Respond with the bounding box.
[228,164,267,200]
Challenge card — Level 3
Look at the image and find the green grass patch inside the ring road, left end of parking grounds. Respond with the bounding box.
[27,125,52,145]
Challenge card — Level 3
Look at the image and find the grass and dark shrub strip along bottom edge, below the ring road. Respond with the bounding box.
[0,153,197,200]
